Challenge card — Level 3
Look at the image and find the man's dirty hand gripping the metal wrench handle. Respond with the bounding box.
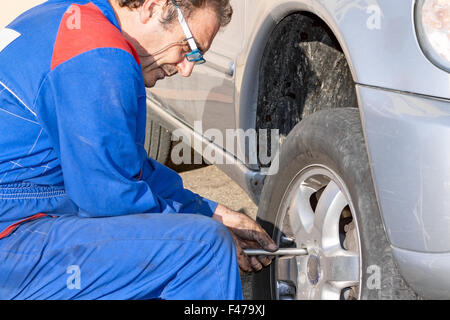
[213,204,278,273]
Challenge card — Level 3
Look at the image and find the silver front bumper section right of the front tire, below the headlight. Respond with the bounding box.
[358,86,450,252]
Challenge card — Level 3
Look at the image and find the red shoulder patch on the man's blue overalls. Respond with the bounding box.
[51,3,140,70]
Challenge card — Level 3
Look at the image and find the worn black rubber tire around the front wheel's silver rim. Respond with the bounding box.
[254,108,400,299]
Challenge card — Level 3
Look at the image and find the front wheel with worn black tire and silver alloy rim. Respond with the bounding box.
[253,108,417,300]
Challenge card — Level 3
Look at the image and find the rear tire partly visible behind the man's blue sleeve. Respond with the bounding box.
[145,114,172,165]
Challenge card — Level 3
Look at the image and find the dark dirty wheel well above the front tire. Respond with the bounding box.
[256,12,358,165]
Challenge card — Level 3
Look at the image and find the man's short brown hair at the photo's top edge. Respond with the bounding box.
[118,0,233,27]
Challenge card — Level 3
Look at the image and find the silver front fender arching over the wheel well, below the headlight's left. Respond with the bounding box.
[236,0,450,158]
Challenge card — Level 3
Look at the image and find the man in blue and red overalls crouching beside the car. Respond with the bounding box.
[0,0,277,299]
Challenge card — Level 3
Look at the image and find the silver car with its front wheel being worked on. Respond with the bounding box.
[147,0,450,299]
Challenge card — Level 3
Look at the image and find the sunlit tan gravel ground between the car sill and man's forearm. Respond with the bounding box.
[169,165,258,300]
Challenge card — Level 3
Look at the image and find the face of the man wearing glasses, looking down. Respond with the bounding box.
[123,1,220,87]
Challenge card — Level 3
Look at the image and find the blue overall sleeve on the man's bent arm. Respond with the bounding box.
[39,48,217,217]
